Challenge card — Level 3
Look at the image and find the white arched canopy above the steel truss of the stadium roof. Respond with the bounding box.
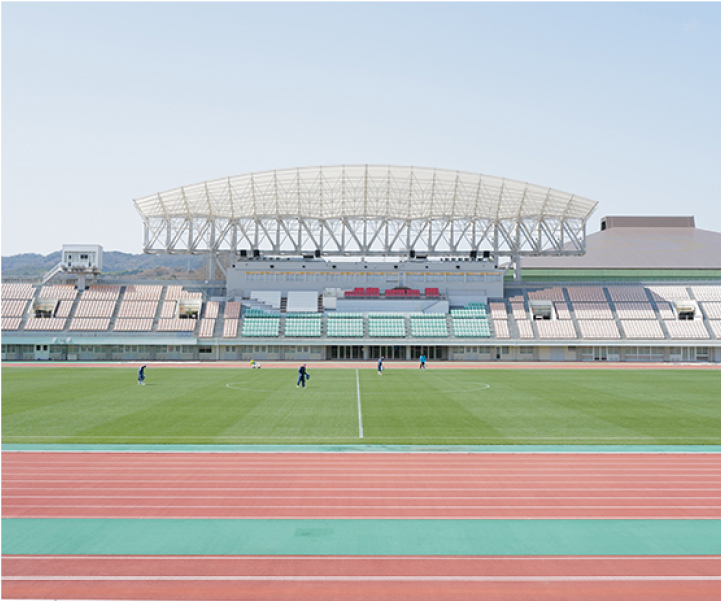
[134,165,597,223]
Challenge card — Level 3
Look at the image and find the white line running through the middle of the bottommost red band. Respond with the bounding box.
[3,576,721,582]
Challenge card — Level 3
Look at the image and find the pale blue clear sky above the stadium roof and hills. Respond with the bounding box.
[1,2,721,256]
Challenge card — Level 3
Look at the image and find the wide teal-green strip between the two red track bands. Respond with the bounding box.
[2,519,721,555]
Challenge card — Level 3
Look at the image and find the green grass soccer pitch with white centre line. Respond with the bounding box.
[2,366,721,444]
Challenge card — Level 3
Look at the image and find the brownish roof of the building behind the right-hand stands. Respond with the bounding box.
[522,216,721,269]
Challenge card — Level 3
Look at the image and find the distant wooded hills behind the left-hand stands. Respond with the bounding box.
[2,251,205,279]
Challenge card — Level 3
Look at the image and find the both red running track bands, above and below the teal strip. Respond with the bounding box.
[2,452,721,601]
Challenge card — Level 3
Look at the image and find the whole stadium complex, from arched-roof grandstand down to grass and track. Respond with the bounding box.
[2,165,721,601]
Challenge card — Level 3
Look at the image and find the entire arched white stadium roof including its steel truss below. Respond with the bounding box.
[134,165,597,258]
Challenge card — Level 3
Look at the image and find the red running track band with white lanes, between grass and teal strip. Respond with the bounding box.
[2,452,721,519]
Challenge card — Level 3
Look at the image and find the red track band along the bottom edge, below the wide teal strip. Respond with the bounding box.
[3,556,721,601]
